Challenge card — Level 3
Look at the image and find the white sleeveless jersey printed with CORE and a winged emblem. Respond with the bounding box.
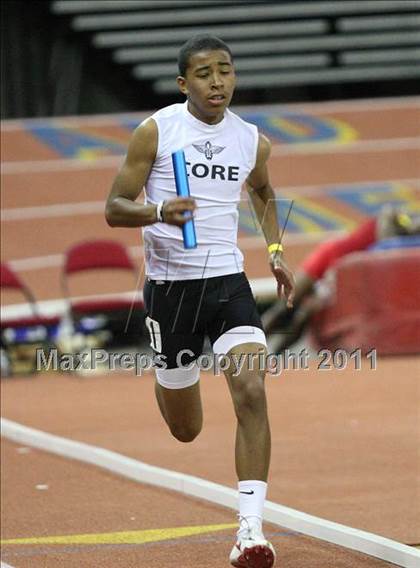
[143,103,258,280]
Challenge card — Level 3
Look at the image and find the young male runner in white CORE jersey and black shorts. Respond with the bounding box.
[106,35,294,568]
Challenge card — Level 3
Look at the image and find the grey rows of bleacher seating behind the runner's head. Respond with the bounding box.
[51,0,420,94]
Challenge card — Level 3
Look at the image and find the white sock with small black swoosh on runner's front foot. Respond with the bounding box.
[238,479,267,532]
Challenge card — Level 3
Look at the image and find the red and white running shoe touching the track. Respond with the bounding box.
[229,527,276,568]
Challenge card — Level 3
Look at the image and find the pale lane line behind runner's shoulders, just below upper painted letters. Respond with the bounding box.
[1,136,420,175]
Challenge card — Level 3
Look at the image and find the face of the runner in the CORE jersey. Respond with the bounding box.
[177,49,235,124]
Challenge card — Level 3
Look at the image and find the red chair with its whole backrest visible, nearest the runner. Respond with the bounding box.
[62,240,144,342]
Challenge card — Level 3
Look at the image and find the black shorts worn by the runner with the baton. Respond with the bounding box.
[143,272,263,369]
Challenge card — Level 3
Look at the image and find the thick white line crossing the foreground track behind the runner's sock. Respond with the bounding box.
[1,418,420,568]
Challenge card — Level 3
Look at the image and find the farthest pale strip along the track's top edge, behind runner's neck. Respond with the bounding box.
[1,96,420,132]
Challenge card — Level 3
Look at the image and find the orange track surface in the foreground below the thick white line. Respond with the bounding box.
[2,442,398,568]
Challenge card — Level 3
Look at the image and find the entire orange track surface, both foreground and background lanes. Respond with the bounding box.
[2,97,420,568]
